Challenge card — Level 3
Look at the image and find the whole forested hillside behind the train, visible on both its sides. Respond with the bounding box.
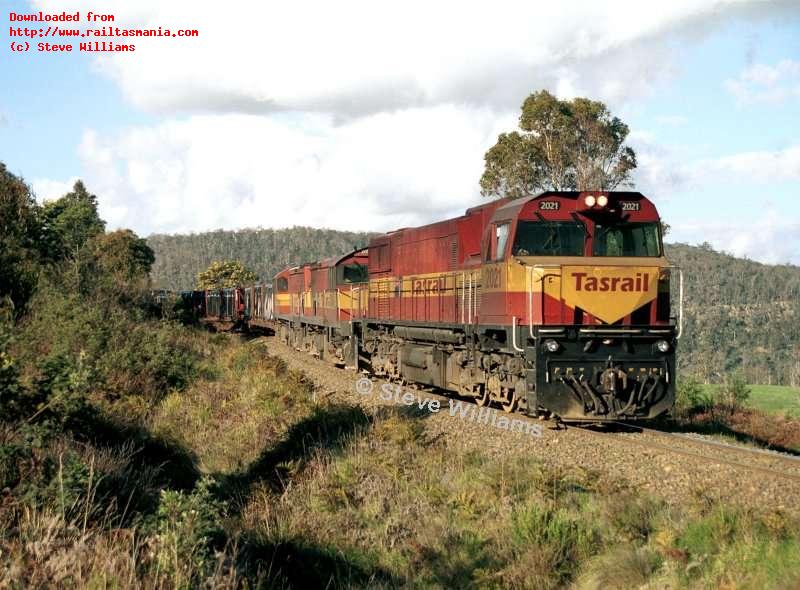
[148,227,800,385]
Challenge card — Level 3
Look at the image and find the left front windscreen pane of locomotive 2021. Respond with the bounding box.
[512,221,586,256]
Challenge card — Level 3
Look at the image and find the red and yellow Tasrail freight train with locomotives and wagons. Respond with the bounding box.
[175,191,683,422]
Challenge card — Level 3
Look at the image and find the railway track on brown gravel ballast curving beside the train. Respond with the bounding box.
[253,337,800,502]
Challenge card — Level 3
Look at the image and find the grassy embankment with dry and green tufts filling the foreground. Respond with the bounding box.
[0,331,800,588]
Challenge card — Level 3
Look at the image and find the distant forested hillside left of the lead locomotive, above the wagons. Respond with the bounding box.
[147,227,371,290]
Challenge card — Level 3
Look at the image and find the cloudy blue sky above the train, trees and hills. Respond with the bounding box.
[0,0,800,264]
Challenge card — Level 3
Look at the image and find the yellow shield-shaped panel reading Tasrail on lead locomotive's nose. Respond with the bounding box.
[561,266,658,324]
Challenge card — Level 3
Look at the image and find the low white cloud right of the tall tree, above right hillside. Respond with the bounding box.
[631,138,800,264]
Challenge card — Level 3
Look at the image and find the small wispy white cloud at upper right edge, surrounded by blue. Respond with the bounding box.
[725,59,800,105]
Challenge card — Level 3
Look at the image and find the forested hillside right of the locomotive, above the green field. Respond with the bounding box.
[667,244,800,386]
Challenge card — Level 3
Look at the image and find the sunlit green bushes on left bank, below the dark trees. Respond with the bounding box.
[10,284,207,418]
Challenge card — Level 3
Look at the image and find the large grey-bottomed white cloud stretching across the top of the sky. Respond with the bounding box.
[33,0,790,118]
